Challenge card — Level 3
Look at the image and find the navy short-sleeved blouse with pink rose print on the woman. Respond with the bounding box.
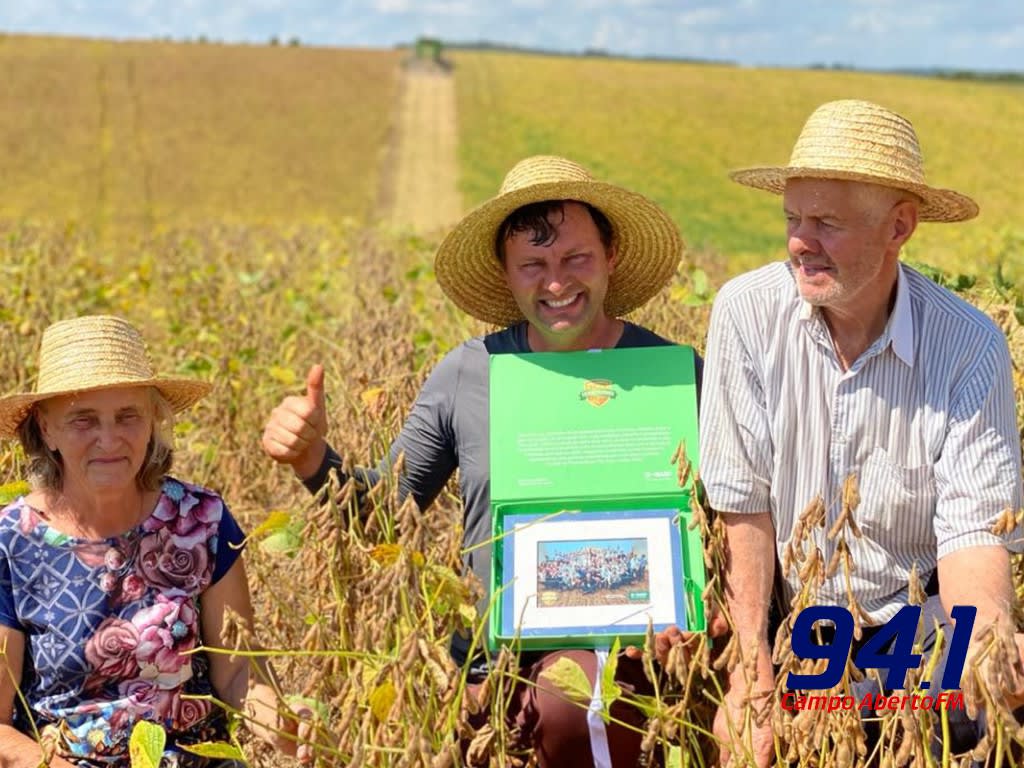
[0,477,244,767]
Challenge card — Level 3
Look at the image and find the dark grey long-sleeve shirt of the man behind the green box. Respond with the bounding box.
[305,322,702,663]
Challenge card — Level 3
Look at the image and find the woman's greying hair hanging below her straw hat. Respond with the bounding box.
[17,387,174,490]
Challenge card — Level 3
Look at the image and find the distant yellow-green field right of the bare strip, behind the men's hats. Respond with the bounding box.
[455,52,1024,278]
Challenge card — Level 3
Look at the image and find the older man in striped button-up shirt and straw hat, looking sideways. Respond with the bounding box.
[700,100,1021,765]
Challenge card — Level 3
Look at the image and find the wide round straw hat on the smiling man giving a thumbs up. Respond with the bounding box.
[434,155,683,326]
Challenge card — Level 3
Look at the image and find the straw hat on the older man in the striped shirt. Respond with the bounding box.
[729,100,978,221]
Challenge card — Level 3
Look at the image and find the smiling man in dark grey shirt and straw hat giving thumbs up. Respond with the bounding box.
[263,157,700,766]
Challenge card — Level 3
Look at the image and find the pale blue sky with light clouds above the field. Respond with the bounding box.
[0,0,1024,72]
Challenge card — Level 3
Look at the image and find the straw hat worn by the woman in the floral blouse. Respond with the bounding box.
[0,315,211,437]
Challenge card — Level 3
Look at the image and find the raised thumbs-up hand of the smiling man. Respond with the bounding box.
[262,364,327,479]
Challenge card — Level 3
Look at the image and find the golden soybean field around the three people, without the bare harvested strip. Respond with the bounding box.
[0,37,1024,768]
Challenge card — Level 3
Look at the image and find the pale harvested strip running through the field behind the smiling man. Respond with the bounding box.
[379,69,462,234]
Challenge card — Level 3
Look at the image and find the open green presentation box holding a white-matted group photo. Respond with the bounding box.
[487,345,705,649]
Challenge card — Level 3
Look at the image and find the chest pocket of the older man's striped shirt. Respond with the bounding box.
[855,447,936,554]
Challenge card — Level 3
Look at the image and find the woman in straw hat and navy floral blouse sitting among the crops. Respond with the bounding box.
[0,316,305,768]
